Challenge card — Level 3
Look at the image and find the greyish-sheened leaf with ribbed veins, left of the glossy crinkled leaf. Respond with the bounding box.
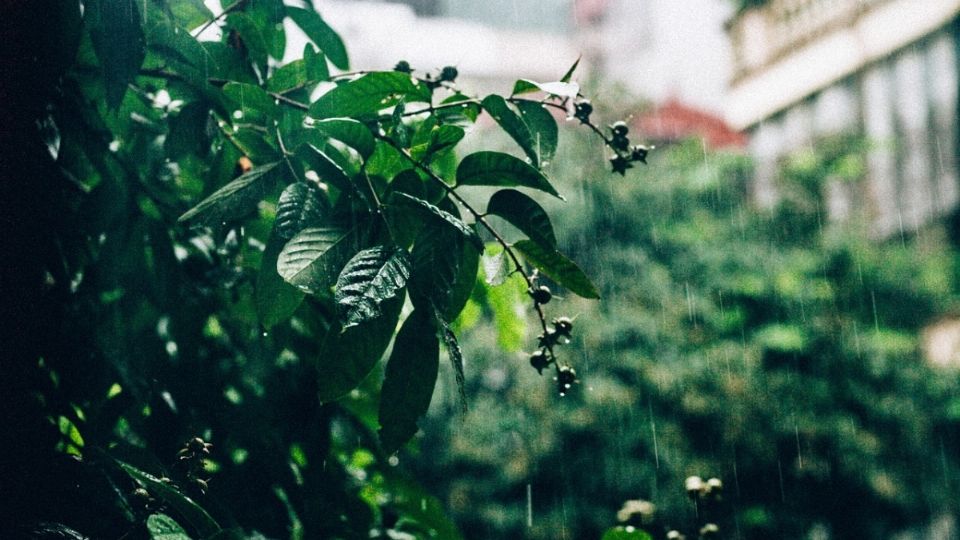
[277,227,368,294]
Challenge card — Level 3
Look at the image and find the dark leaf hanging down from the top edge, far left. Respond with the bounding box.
[84,0,146,108]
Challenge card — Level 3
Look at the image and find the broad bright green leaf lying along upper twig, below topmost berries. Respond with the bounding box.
[310,71,430,118]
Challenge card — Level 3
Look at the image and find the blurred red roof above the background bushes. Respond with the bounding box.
[636,99,747,149]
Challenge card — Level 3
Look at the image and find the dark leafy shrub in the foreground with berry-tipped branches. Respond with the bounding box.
[0,0,645,539]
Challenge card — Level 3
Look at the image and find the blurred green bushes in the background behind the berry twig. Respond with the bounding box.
[417,132,960,538]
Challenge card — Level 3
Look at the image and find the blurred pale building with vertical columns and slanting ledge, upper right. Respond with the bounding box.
[725,0,960,238]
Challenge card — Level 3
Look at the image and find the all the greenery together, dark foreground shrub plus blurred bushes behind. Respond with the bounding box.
[0,0,960,540]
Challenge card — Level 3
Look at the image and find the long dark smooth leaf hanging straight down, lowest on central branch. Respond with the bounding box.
[380,309,440,454]
